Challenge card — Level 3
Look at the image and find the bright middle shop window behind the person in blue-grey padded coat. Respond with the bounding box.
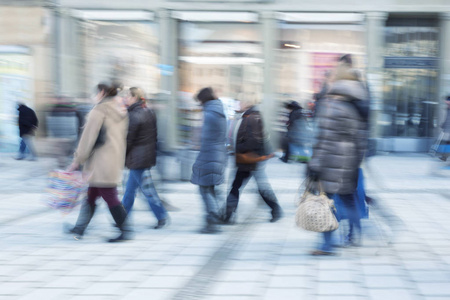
[178,21,264,148]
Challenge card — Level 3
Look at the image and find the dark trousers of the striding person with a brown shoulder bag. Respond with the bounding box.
[227,166,281,215]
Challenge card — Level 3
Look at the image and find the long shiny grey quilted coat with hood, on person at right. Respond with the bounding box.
[309,79,367,194]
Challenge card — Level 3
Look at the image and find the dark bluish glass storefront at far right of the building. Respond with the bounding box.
[378,20,439,137]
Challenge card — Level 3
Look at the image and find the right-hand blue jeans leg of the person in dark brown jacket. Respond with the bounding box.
[138,169,167,221]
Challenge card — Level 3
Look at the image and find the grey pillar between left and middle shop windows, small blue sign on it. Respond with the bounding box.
[158,10,178,150]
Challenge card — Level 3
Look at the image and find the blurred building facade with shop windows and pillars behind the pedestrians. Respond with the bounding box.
[0,0,450,152]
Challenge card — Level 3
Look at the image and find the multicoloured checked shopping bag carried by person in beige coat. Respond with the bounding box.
[44,170,87,214]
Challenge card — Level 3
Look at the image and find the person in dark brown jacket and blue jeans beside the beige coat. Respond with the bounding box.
[122,87,168,229]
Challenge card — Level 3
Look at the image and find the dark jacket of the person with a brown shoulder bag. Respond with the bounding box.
[235,106,272,171]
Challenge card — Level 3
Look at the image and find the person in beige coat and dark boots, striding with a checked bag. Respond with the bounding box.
[68,83,130,242]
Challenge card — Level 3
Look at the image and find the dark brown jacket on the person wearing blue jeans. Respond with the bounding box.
[125,101,157,169]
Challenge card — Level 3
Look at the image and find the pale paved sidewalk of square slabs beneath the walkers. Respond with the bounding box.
[0,155,450,300]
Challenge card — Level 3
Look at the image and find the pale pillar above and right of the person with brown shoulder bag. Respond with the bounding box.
[260,11,279,146]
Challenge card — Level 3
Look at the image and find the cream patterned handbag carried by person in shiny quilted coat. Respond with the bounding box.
[295,179,339,232]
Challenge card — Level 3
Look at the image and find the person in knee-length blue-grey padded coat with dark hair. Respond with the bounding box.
[191,87,227,233]
